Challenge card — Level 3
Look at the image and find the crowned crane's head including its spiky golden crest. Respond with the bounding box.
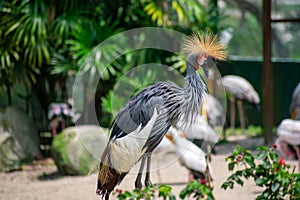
[184,32,227,76]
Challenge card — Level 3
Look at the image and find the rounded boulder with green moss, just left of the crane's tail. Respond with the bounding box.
[51,125,108,175]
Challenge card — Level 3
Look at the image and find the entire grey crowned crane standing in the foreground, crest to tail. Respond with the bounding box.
[96,34,226,199]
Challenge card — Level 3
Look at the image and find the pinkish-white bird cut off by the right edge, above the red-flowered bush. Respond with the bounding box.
[276,119,300,171]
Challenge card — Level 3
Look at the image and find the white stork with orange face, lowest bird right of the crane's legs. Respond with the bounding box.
[166,127,213,183]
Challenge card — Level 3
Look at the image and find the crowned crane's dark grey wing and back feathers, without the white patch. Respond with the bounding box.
[110,82,179,152]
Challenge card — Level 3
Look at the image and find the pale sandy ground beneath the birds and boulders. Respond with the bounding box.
[0,139,298,200]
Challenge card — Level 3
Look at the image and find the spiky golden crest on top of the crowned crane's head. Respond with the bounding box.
[183,32,227,60]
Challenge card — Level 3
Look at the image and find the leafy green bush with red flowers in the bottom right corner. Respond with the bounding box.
[221,145,300,199]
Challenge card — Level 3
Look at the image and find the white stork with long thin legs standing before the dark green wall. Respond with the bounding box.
[222,75,260,130]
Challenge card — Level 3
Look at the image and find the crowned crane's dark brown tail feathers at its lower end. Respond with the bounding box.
[96,163,127,200]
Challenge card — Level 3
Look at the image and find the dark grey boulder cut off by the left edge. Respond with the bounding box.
[0,107,40,171]
